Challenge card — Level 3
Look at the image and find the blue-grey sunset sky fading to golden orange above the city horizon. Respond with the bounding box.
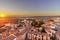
[0,0,60,16]
